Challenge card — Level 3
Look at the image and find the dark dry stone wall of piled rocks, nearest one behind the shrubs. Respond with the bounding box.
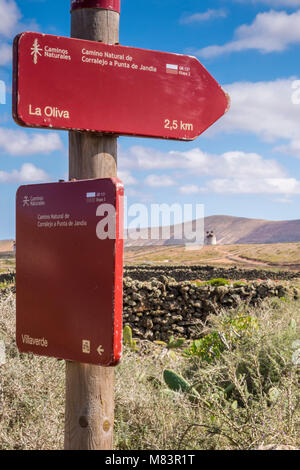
[123,276,298,341]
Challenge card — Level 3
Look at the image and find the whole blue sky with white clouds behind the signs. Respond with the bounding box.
[0,0,300,239]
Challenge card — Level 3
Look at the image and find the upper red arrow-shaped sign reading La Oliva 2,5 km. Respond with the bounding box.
[13,33,229,140]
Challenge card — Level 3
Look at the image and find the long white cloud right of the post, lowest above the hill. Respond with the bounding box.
[124,147,292,195]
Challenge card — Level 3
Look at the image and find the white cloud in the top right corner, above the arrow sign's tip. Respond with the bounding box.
[194,10,300,58]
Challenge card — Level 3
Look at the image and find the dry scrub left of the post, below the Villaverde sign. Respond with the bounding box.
[0,293,64,450]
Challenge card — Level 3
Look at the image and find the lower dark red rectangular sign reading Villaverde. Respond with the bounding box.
[16,179,123,366]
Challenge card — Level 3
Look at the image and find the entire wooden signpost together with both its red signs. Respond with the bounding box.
[13,0,229,450]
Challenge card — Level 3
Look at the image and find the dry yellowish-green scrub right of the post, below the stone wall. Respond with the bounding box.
[116,300,300,450]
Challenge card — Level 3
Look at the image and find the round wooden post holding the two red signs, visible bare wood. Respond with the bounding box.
[65,0,120,450]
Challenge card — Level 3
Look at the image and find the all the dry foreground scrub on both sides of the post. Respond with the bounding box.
[0,293,300,450]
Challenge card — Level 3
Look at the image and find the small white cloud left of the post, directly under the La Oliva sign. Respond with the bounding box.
[0,128,63,155]
